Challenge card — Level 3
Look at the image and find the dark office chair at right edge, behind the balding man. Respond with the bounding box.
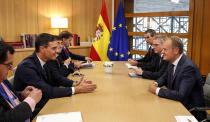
[189,73,210,121]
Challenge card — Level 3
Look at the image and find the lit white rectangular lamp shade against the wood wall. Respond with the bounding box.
[51,18,68,28]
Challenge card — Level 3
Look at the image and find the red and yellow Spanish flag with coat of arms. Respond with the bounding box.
[90,0,111,61]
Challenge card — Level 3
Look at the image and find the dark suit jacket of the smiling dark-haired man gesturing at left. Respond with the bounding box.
[14,53,72,98]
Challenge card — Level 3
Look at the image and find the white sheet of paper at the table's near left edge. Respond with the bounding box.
[36,112,82,122]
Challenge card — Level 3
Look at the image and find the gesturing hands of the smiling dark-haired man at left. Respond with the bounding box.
[75,78,97,94]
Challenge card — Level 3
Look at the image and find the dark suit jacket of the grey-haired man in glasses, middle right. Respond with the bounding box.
[142,56,169,80]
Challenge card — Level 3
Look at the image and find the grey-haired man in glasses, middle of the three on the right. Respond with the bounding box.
[134,35,169,80]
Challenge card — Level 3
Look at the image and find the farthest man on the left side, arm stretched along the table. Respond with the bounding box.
[59,31,92,68]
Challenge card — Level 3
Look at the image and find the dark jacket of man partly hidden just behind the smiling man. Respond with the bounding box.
[56,55,75,77]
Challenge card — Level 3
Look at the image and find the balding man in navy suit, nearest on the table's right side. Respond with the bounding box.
[149,36,206,121]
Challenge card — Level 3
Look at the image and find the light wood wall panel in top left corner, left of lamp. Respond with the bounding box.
[0,0,38,41]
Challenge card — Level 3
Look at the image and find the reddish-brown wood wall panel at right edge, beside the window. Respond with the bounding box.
[192,0,210,75]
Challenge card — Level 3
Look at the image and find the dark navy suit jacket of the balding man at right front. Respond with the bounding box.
[156,55,204,109]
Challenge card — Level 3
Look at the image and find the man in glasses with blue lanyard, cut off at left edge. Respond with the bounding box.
[0,40,42,122]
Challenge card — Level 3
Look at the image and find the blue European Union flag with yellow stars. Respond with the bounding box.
[107,0,130,61]
